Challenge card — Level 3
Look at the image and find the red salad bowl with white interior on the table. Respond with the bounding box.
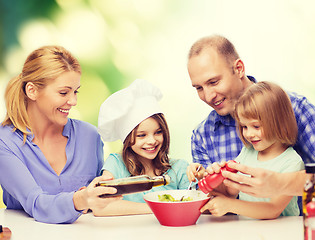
[144,190,209,227]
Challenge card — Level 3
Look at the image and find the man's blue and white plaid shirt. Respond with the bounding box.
[191,84,315,167]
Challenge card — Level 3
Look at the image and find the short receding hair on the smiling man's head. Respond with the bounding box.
[188,35,240,67]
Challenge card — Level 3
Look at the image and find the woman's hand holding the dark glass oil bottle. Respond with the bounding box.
[73,176,122,211]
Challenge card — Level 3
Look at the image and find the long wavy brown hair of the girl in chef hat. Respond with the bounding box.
[122,113,171,176]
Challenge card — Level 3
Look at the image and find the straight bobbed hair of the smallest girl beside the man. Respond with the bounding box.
[233,82,298,146]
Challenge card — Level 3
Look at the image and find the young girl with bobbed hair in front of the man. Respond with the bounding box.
[201,82,304,219]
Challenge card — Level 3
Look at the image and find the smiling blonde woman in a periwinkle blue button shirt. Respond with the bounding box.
[0,46,117,223]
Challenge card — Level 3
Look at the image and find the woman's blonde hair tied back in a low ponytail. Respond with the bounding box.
[2,46,81,142]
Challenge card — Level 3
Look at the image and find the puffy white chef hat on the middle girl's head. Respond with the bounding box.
[98,79,162,142]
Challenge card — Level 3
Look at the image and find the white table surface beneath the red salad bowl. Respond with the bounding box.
[0,209,303,240]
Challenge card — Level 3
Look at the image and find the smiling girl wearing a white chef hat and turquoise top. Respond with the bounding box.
[93,80,189,216]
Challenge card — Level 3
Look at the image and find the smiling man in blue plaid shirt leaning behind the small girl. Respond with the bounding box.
[188,36,315,197]
